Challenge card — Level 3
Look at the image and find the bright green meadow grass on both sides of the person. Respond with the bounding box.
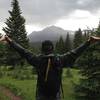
[0,70,80,100]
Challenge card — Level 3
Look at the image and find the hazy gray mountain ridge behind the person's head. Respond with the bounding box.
[28,26,74,43]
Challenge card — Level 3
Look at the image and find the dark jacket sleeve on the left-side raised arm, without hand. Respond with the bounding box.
[9,41,38,66]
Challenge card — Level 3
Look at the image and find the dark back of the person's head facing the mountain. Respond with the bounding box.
[41,40,54,54]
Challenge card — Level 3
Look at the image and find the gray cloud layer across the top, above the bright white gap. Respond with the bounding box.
[0,0,100,25]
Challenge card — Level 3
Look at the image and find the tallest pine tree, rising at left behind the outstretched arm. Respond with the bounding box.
[3,0,29,66]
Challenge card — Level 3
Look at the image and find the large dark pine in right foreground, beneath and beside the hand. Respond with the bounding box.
[75,24,100,100]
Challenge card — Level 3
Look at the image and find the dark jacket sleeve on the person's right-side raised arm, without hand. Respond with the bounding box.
[61,41,90,67]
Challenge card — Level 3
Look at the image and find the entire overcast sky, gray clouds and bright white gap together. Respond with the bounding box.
[0,0,100,33]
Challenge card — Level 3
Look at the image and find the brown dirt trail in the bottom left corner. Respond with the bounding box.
[0,86,22,100]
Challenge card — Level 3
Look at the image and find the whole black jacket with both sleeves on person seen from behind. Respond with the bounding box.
[9,41,90,97]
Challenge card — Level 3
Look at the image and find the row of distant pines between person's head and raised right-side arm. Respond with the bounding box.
[55,28,91,54]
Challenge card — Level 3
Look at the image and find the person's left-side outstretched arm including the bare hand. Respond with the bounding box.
[0,35,37,66]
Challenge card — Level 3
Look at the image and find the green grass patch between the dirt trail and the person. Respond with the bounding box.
[0,77,36,100]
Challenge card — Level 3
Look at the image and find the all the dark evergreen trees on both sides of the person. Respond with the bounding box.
[0,0,100,100]
